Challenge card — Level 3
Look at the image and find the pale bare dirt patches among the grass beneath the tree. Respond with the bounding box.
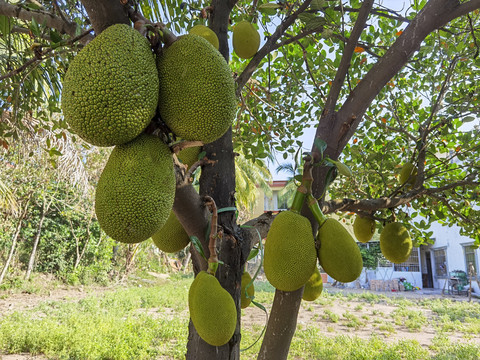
[0,284,480,360]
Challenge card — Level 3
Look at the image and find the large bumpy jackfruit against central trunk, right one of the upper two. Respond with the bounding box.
[157,34,237,143]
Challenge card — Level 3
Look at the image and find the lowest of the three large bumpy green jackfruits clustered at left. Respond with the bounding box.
[95,134,176,243]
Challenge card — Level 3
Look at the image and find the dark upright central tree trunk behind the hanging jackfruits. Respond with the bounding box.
[186,0,250,360]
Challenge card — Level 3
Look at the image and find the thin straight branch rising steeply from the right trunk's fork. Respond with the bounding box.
[324,0,374,112]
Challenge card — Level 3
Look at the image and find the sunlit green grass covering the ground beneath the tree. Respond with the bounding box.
[0,276,480,360]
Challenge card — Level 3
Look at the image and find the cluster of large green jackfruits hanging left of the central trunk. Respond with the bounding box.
[62,24,236,251]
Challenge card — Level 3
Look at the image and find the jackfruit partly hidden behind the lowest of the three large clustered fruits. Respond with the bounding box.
[152,211,190,253]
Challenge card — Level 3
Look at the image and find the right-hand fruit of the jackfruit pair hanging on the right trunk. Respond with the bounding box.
[317,218,363,283]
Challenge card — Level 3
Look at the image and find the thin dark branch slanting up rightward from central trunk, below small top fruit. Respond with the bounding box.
[236,0,312,97]
